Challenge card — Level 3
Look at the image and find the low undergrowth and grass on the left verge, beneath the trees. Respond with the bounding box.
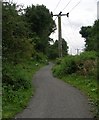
[2,55,47,118]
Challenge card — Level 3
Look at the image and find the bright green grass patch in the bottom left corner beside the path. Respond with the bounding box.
[2,89,33,118]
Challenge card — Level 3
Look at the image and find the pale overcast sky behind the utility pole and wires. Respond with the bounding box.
[10,0,99,54]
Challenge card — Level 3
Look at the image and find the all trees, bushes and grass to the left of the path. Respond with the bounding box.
[0,2,55,118]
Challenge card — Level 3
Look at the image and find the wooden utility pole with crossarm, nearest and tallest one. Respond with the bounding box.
[51,12,69,57]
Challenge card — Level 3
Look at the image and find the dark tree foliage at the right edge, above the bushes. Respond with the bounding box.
[80,20,99,51]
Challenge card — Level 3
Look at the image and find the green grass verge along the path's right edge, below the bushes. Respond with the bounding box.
[61,74,98,117]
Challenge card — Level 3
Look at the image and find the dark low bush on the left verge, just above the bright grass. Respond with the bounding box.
[2,64,30,90]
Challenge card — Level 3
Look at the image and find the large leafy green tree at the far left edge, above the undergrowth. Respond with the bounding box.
[2,2,33,63]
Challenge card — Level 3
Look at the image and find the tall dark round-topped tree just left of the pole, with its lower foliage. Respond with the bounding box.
[24,5,56,53]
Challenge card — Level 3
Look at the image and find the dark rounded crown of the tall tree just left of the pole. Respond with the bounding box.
[25,5,55,37]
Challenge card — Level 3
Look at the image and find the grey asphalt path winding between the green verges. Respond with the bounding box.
[16,63,92,118]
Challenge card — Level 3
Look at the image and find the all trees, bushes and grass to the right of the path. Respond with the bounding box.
[53,20,99,118]
